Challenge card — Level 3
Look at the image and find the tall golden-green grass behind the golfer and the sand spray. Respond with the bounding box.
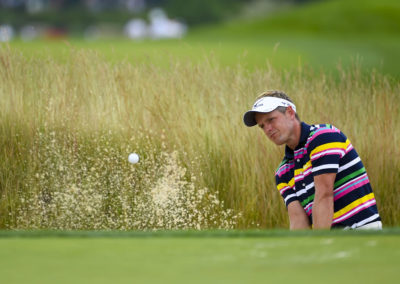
[0,48,400,229]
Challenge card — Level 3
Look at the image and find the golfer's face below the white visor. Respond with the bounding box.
[255,109,295,145]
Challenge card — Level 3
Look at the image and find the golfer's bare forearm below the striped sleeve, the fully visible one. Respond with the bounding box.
[312,173,336,229]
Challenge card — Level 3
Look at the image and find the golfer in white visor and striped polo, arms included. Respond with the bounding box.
[243,91,382,230]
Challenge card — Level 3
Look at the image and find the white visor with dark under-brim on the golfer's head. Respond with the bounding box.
[243,97,296,127]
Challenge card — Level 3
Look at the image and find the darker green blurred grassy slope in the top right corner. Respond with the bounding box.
[205,0,400,37]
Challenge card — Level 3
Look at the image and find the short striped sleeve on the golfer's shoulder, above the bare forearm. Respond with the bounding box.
[308,127,351,176]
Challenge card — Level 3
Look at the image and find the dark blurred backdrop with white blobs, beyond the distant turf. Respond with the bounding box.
[0,0,306,41]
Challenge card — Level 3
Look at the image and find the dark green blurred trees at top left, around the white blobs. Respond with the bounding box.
[0,0,250,31]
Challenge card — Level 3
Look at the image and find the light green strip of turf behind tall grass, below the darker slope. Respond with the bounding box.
[10,33,400,77]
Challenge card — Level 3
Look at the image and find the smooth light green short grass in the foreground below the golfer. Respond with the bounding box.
[0,230,400,283]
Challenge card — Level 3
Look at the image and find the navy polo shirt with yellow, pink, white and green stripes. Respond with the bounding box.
[275,122,381,228]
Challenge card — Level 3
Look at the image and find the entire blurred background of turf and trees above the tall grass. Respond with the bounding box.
[0,0,400,78]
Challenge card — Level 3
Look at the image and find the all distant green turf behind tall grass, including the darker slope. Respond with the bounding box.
[5,0,400,77]
